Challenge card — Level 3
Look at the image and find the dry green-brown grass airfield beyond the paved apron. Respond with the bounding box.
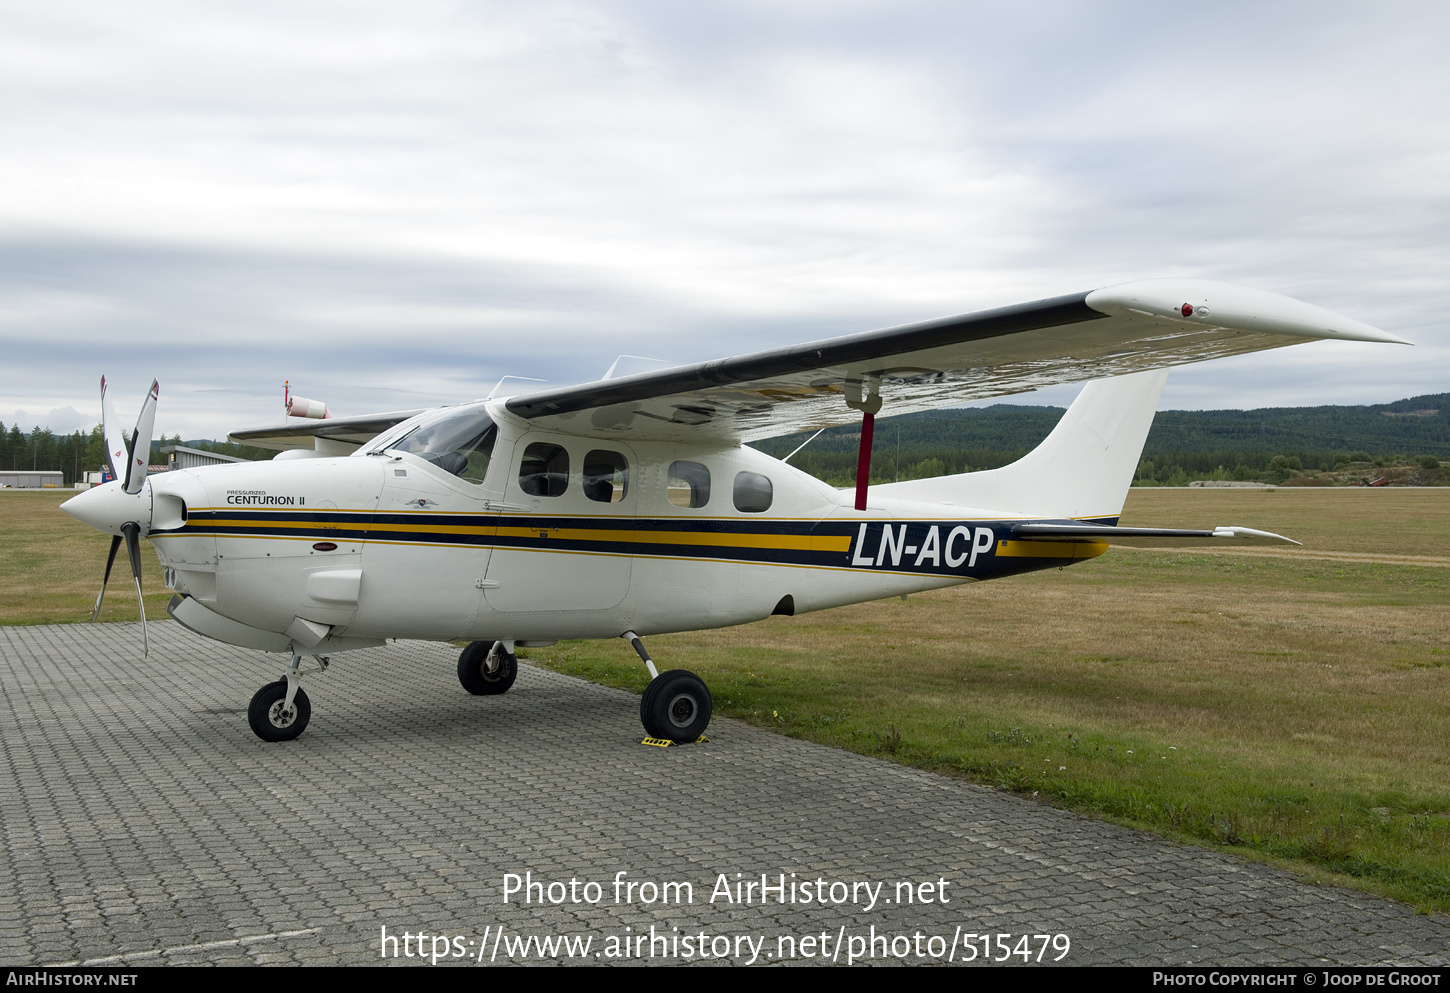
[0,489,1450,912]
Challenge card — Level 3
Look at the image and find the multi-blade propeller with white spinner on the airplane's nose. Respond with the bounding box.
[77,375,160,657]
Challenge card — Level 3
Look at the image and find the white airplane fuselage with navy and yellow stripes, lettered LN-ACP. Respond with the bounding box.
[141,404,1080,651]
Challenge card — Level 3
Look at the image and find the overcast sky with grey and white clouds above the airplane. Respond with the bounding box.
[0,0,1450,438]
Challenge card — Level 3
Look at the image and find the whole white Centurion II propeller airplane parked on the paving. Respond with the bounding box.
[62,278,1411,742]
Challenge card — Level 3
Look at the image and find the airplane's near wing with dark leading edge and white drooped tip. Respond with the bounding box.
[501,278,1409,442]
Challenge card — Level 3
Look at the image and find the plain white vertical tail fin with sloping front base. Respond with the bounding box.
[870,363,1169,519]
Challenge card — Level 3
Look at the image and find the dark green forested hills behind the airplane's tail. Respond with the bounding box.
[755,393,1450,480]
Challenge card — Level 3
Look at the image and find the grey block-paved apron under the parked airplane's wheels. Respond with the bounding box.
[0,622,1450,965]
